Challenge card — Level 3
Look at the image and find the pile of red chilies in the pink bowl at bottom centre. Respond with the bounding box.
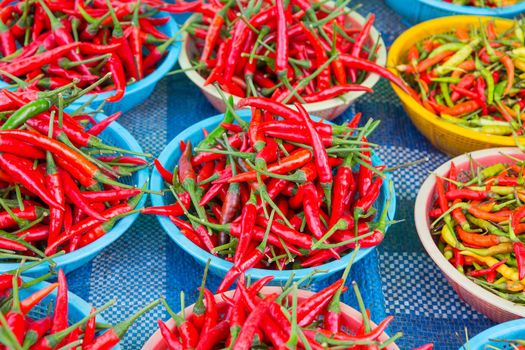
[157,254,432,350]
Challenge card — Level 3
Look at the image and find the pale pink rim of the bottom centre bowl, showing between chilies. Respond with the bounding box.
[142,286,399,350]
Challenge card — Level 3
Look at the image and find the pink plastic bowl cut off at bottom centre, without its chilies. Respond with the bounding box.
[142,287,399,350]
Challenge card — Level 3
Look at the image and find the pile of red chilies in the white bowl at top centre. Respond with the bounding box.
[172,0,405,103]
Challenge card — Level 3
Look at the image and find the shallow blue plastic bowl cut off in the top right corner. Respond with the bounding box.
[385,0,525,25]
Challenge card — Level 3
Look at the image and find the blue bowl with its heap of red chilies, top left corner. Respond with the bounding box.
[0,0,180,114]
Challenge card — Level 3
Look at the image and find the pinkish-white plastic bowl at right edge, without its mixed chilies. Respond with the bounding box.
[414,147,525,322]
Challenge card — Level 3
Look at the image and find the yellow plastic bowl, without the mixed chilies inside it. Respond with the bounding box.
[387,16,516,156]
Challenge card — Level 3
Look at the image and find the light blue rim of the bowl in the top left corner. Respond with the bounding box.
[0,11,182,105]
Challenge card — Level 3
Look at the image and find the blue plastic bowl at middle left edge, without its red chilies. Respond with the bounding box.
[0,107,149,277]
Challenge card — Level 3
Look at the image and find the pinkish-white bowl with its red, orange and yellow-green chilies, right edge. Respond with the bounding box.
[415,148,525,322]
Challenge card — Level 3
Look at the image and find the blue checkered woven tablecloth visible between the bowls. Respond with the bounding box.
[65,0,500,349]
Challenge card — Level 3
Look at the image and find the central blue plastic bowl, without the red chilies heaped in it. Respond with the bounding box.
[150,110,396,284]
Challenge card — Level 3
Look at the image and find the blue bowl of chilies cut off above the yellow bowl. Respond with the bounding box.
[385,0,525,25]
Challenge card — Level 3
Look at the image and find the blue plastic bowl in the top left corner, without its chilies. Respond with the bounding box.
[0,12,181,115]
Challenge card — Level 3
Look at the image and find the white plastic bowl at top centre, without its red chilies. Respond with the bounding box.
[179,7,386,120]
